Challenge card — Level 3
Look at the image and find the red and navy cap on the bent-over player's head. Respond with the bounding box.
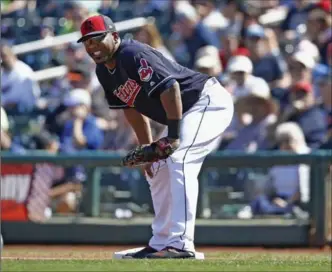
[77,15,116,43]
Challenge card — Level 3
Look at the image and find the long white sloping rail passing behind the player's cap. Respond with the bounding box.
[13,17,154,55]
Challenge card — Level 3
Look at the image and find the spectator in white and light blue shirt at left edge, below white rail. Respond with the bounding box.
[1,44,40,113]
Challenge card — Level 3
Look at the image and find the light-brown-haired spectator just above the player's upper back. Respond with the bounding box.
[135,23,175,60]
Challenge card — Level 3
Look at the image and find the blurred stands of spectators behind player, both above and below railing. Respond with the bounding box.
[1,0,332,246]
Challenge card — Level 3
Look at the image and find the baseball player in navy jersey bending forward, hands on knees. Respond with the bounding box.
[78,15,233,258]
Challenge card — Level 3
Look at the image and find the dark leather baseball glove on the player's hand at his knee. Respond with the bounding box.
[122,137,175,167]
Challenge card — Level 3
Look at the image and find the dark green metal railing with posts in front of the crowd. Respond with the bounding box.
[1,151,332,244]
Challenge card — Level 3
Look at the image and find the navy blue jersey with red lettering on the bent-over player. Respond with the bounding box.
[96,40,209,124]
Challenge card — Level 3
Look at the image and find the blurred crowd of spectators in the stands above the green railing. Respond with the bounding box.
[1,0,332,217]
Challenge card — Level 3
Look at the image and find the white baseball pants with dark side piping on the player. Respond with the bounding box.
[147,78,234,251]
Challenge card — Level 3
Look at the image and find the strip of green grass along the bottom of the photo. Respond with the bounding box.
[2,252,332,272]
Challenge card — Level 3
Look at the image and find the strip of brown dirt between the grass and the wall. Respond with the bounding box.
[2,245,332,260]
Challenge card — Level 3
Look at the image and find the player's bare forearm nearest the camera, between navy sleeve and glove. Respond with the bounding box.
[160,81,182,148]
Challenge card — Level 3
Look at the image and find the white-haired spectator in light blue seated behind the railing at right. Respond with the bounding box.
[238,122,310,219]
